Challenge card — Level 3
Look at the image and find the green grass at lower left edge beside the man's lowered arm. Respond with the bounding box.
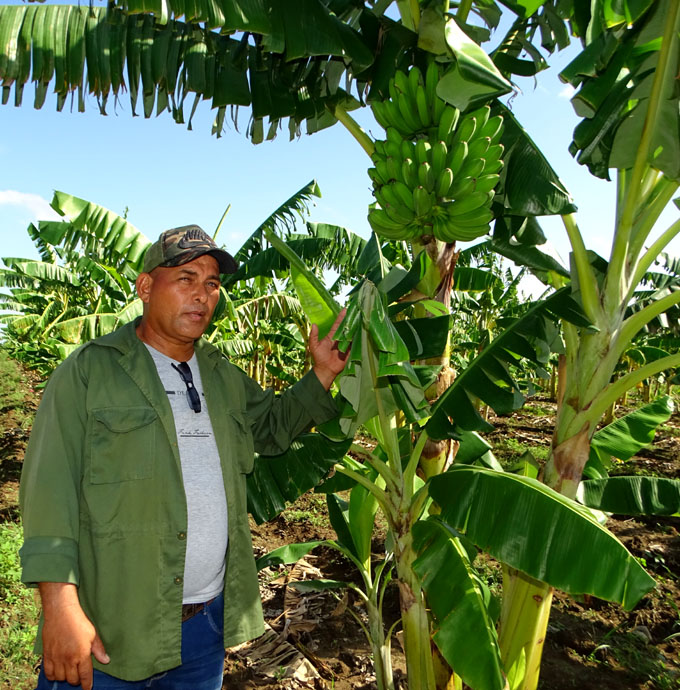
[0,523,38,690]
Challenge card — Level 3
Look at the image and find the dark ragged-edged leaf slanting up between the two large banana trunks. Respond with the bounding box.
[426,288,588,438]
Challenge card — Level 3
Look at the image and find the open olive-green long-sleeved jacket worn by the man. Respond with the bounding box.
[20,323,336,680]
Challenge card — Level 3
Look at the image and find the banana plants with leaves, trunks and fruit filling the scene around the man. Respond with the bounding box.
[0,0,680,690]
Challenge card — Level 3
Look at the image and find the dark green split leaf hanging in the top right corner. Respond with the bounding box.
[560,0,680,179]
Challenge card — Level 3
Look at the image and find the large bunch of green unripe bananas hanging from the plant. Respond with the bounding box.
[368,63,503,242]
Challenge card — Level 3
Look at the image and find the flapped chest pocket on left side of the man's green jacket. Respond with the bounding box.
[90,407,158,484]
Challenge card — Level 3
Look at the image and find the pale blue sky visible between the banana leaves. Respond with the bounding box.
[0,13,680,288]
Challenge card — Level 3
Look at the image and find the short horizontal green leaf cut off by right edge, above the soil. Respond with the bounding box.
[577,477,680,515]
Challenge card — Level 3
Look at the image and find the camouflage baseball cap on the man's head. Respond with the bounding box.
[143,225,238,273]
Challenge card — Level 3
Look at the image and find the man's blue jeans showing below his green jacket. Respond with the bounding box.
[36,594,224,690]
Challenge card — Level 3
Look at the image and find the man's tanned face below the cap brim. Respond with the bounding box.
[137,254,220,345]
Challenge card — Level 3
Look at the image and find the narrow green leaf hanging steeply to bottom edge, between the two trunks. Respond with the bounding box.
[413,520,505,690]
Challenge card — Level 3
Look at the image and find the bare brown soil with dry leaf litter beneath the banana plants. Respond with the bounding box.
[0,370,680,690]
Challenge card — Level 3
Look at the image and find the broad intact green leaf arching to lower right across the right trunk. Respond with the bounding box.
[429,465,654,609]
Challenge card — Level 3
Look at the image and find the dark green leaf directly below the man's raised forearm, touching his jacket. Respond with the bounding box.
[246,433,351,524]
